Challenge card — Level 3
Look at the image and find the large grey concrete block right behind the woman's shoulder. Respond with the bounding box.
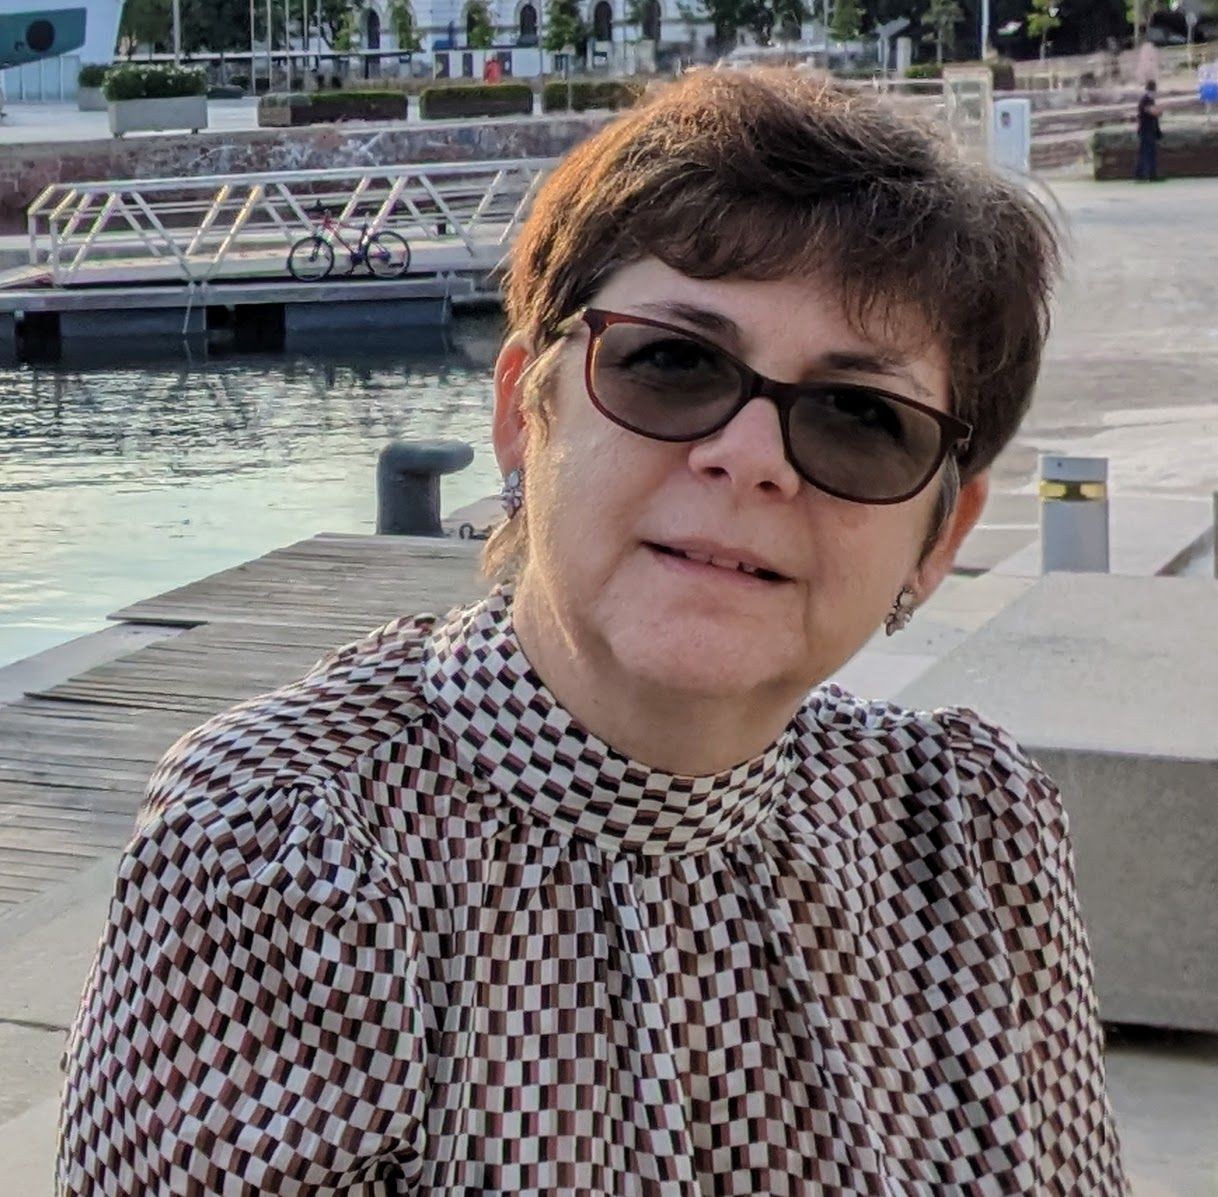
[898,574,1218,1031]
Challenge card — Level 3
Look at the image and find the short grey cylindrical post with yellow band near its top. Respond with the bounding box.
[1040,453,1108,574]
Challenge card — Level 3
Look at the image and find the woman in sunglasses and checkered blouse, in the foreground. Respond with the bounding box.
[58,72,1125,1197]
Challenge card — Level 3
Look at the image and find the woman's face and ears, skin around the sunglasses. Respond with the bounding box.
[496,258,984,699]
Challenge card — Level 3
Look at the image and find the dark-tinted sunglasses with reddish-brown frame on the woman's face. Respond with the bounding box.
[571,308,972,504]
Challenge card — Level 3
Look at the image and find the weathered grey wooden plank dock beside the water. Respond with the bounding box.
[0,535,487,914]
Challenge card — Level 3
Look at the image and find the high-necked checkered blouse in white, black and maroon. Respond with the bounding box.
[58,594,1125,1197]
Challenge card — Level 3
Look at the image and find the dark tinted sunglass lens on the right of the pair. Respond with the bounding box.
[790,386,943,503]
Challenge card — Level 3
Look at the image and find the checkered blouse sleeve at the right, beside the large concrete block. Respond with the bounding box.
[949,711,1129,1197]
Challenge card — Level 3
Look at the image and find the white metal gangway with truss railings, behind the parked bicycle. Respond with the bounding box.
[15,158,557,289]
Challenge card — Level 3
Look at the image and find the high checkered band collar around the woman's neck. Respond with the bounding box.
[423,589,795,855]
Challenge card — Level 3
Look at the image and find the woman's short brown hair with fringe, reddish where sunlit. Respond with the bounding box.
[484,68,1060,577]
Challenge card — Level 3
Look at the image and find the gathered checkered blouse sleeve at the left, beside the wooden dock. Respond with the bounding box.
[56,782,425,1197]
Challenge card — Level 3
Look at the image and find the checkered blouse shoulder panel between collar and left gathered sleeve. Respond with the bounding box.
[141,615,435,822]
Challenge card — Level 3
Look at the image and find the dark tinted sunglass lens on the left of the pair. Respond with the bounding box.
[592,324,743,440]
